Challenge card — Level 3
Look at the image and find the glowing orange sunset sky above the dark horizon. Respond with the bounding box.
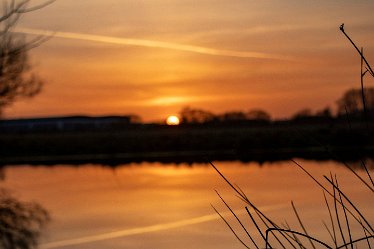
[5,0,374,121]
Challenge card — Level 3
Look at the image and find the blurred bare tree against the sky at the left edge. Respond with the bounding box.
[0,0,55,114]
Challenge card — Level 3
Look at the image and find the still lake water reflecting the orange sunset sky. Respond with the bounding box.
[0,160,374,249]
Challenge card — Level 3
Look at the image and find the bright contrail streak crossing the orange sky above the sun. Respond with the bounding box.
[15,28,289,60]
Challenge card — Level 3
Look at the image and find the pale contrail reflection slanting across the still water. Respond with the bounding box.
[39,205,285,249]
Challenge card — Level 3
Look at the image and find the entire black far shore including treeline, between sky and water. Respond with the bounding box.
[0,86,374,164]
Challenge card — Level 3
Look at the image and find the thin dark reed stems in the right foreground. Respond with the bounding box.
[211,24,374,249]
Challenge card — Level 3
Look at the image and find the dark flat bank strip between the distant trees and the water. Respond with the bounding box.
[0,120,374,165]
